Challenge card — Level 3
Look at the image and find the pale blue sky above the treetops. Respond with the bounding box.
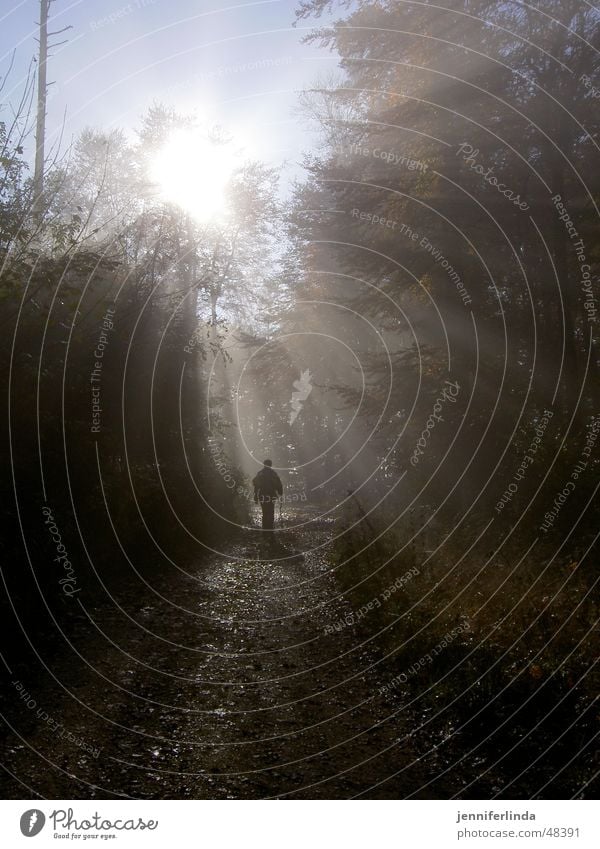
[0,0,336,177]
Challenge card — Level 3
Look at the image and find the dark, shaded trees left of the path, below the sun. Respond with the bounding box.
[0,89,276,656]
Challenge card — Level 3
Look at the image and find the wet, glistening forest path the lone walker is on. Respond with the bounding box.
[2,511,423,798]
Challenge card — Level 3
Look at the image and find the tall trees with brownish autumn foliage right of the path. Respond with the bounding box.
[292,0,599,518]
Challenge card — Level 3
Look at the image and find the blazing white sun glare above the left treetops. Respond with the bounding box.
[150,130,241,221]
